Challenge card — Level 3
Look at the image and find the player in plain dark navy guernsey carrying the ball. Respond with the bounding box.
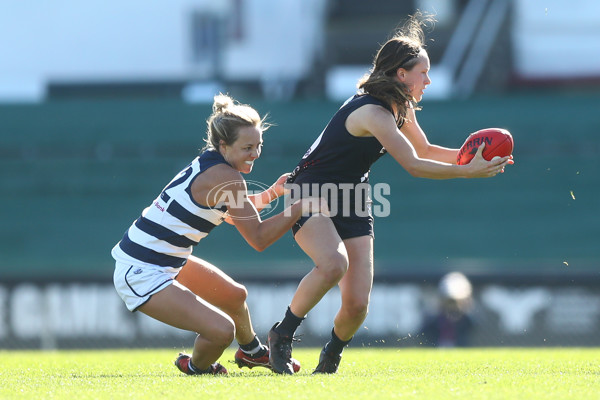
[269,13,512,374]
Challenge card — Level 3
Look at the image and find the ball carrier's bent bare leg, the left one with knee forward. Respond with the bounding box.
[290,214,348,318]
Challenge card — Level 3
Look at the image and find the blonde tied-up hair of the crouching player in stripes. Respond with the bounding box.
[202,93,270,151]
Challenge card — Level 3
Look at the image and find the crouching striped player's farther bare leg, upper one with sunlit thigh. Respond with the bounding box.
[177,256,255,344]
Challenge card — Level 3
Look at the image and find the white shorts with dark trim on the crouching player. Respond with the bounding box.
[113,261,181,311]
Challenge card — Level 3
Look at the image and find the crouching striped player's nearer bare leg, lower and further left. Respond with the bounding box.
[139,281,235,369]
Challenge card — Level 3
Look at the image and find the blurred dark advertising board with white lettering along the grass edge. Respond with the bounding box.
[0,276,600,349]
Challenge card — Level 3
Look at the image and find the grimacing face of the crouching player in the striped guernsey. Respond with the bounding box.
[221,126,262,174]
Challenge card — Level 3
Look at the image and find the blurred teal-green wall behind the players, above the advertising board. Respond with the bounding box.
[0,93,600,282]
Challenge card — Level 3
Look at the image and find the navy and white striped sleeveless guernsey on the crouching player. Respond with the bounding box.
[112,150,227,267]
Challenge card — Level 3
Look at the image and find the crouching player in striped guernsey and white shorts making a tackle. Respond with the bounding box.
[112,95,326,375]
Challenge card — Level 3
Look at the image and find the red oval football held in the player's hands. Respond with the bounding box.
[456,128,514,165]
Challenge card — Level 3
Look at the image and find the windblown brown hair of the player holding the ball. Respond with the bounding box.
[357,11,435,125]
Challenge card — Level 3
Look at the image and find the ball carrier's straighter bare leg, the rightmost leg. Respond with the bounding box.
[334,236,373,341]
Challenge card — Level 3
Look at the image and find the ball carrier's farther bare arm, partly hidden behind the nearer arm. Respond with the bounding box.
[400,108,459,164]
